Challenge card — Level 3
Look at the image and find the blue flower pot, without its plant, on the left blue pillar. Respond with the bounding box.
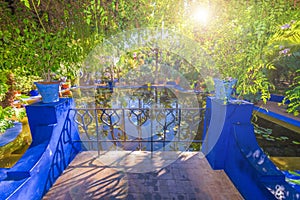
[34,82,60,103]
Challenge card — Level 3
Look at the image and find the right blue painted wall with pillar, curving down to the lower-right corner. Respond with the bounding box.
[202,97,300,199]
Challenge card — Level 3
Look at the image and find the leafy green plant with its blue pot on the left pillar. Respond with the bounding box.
[35,31,80,103]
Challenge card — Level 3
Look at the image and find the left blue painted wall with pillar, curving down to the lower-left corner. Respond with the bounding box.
[0,99,81,200]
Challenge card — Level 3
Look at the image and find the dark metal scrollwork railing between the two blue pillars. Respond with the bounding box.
[73,108,204,151]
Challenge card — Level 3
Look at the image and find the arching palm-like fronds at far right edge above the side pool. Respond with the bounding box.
[269,20,300,116]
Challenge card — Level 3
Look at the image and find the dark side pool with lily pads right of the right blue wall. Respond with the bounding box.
[253,117,300,191]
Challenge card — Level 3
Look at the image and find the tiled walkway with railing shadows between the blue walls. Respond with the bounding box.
[44,151,243,200]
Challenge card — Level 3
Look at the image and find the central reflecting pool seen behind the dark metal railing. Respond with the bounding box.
[73,85,205,151]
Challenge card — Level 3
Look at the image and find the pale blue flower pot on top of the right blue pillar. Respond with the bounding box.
[214,78,237,100]
